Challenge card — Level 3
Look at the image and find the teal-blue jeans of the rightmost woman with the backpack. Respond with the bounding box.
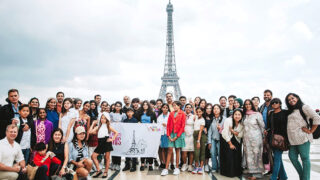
[289,141,311,180]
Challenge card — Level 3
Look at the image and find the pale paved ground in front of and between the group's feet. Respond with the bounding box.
[90,143,320,180]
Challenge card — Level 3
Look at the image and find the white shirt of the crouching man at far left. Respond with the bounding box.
[0,137,24,167]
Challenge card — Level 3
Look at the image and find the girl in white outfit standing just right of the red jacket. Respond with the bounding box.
[181,104,194,172]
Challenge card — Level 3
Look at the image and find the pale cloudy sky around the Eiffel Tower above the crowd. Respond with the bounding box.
[0,0,320,108]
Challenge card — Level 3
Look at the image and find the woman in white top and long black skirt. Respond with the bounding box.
[220,109,243,179]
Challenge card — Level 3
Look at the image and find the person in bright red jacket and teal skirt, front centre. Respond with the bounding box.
[161,101,186,176]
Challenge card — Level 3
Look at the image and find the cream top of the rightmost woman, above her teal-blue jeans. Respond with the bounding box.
[287,105,320,145]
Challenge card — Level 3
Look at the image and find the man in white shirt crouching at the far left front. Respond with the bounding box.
[0,124,27,180]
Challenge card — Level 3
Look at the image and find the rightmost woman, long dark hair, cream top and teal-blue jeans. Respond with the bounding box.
[286,93,320,180]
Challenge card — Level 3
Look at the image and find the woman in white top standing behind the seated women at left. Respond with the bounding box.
[59,98,76,143]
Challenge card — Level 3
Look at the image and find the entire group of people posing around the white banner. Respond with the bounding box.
[0,89,320,180]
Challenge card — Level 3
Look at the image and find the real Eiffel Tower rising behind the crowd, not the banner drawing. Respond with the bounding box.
[159,0,181,100]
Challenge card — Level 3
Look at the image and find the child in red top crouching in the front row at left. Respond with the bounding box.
[33,142,61,180]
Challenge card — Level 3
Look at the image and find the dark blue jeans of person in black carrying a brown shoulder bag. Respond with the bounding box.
[270,149,288,180]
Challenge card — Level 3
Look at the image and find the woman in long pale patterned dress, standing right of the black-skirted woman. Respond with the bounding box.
[242,99,264,179]
